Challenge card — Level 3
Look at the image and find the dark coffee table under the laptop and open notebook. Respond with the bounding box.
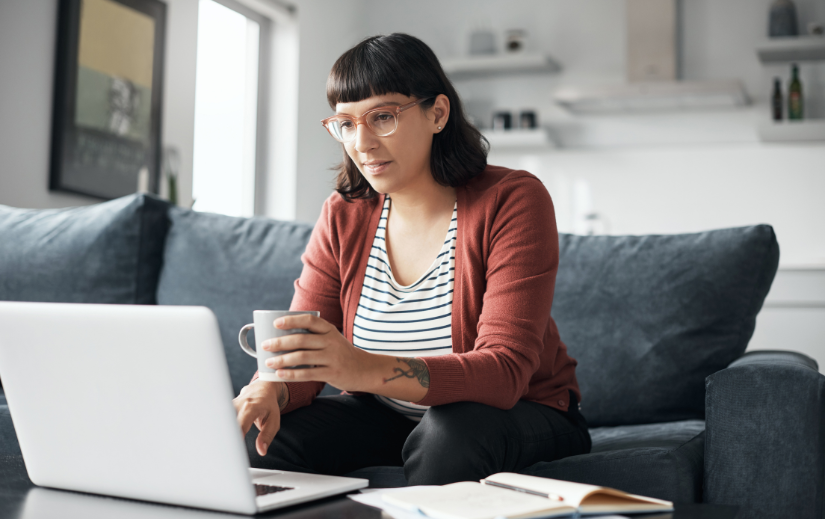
[0,457,737,519]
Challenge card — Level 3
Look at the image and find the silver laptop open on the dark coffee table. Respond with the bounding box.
[0,302,368,514]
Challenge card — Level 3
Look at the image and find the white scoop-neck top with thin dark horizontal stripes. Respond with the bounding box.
[352,196,458,421]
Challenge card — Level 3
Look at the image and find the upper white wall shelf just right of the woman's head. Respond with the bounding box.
[441,53,561,79]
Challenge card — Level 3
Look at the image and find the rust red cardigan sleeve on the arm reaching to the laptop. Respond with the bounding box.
[252,193,344,414]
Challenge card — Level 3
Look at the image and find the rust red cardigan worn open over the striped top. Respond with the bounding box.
[270,166,581,412]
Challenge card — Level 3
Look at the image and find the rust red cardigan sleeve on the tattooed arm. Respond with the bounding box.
[416,177,559,409]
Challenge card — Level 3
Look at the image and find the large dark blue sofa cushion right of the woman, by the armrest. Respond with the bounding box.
[551,225,779,426]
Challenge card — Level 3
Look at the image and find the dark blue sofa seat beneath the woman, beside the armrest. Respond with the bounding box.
[348,420,705,502]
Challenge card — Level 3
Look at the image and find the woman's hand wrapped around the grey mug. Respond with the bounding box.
[262,314,373,391]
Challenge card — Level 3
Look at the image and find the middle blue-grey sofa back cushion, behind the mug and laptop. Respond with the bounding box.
[157,208,312,394]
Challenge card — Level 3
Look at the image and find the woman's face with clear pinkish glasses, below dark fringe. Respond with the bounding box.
[335,94,450,193]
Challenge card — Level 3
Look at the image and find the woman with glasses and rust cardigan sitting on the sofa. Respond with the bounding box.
[235,34,590,485]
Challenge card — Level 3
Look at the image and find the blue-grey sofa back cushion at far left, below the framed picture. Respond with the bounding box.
[0,195,169,304]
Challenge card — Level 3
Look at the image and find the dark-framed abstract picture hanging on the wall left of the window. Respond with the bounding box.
[49,0,166,199]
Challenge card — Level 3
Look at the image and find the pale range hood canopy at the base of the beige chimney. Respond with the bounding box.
[553,79,749,113]
